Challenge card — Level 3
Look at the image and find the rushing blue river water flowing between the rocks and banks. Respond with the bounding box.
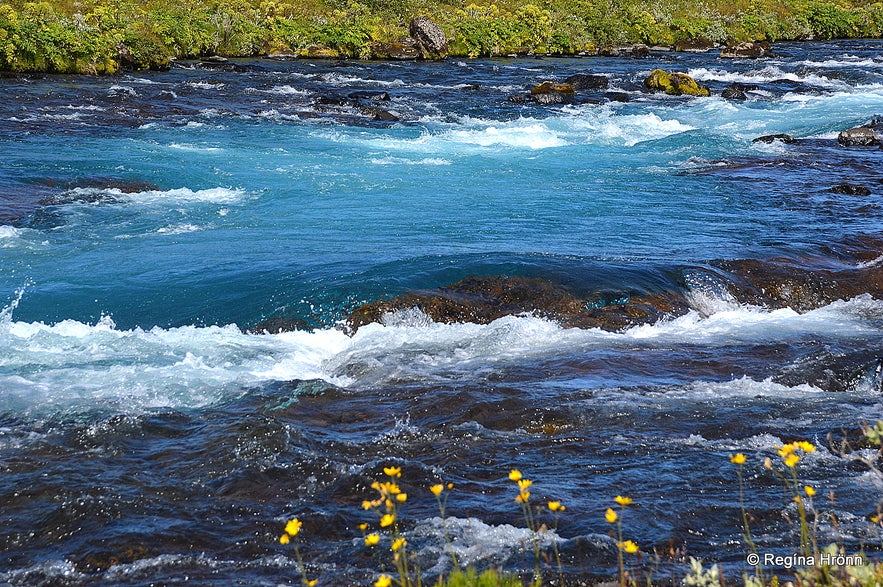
[0,41,883,585]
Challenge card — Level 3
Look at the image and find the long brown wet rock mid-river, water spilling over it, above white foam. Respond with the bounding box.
[347,276,688,332]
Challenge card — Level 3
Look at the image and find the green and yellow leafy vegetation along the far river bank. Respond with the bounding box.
[0,0,883,74]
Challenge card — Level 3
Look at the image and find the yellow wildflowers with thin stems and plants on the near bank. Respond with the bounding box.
[279,420,883,587]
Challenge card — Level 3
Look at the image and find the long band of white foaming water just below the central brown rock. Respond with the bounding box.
[0,296,883,412]
